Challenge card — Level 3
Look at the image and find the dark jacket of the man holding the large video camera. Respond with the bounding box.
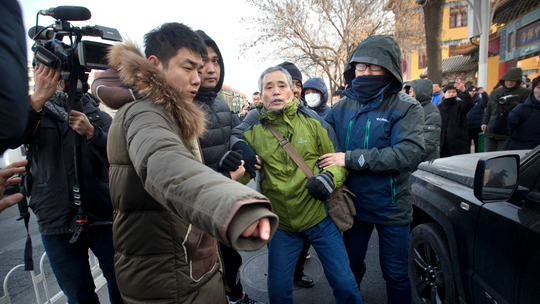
[24,94,113,235]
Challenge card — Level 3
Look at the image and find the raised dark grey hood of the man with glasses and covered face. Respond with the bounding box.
[343,35,403,85]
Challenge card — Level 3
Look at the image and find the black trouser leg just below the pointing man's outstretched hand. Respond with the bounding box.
[219,243,243,301]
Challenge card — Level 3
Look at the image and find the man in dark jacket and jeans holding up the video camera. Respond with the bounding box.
[19,65,123,304]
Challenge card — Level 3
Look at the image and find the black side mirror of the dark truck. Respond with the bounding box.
[474,155,519,203]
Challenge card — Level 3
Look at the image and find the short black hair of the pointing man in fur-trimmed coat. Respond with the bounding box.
[144,22,208,69]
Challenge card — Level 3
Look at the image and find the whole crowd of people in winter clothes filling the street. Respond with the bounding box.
[0,1,540,304]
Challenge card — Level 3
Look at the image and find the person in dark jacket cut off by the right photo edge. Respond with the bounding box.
[492,77,540,150]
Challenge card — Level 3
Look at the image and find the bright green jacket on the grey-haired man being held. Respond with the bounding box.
[238,98,348,232]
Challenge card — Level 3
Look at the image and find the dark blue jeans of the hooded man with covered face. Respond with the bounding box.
[344,220,411,304]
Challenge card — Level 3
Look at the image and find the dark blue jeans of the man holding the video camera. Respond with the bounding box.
[41,225,124,304]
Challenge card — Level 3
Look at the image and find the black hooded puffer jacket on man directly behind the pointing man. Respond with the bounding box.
[193,30,234,176]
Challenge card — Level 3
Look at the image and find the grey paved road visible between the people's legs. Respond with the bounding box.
[0,180,386,304]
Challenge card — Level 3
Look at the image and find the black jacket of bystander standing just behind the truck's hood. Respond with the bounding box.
[438,92,474,155]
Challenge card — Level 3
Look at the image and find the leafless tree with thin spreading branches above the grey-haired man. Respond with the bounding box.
[242,0,394,91]
